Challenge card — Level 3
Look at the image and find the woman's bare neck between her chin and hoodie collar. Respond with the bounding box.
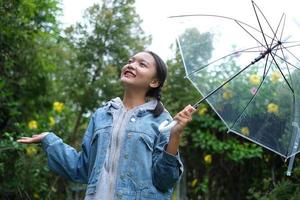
[123,91,146,109]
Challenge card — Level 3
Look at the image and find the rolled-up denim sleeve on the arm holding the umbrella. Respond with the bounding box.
[152,128,183,192]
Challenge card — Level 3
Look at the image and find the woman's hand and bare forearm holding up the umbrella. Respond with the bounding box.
[166,105,196,155]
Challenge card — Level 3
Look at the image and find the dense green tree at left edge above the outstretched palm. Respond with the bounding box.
[0,0,59,134]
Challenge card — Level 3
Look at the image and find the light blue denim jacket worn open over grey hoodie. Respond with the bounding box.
[42,98,183,200]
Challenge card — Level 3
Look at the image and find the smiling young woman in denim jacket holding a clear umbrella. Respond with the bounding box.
[18,51,195,200]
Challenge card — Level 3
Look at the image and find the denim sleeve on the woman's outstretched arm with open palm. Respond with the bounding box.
[42,113,94,183]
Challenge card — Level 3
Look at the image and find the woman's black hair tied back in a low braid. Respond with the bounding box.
[144,51,167,117]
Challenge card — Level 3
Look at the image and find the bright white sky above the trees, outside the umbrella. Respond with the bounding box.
[61,0,300,60]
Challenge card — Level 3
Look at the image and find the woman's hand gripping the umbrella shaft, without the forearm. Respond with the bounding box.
[171,105,196,136]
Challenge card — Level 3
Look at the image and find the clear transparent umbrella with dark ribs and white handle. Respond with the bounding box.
[159,1,300,175]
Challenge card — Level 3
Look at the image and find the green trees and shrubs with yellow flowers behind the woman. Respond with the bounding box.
[0,0,300,199]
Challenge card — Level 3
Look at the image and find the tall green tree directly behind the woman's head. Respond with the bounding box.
[58,0,150,141]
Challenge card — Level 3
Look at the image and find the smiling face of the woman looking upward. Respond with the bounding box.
[121,52,159,92]
